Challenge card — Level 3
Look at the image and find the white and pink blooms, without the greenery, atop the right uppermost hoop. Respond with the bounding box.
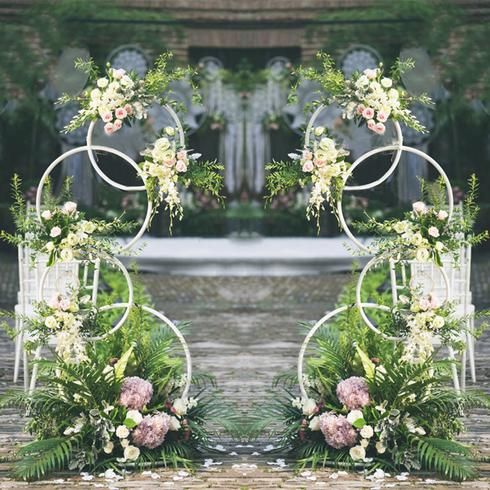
[344,68,404,134]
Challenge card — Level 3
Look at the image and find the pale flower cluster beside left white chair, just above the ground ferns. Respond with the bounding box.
[24,289,97,364]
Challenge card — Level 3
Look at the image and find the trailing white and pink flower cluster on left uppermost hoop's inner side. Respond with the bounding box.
[140,126,201,215]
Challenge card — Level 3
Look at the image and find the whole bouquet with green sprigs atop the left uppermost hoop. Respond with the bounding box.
[58,52,190,135]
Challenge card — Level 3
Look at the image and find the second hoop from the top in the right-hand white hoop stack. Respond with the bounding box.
[337,145,454,252]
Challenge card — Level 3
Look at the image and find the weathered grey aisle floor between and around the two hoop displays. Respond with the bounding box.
[0,256,490,490]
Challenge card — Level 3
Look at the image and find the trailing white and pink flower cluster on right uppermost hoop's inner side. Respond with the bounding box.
[289,126,349,223]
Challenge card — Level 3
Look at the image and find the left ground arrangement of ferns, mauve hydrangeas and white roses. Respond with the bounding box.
[0,273,234,480]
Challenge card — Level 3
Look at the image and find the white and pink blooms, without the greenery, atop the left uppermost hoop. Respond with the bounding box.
[87,68,147,134]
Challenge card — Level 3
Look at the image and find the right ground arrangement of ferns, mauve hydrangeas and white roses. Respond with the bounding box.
[257,312,490,481]
